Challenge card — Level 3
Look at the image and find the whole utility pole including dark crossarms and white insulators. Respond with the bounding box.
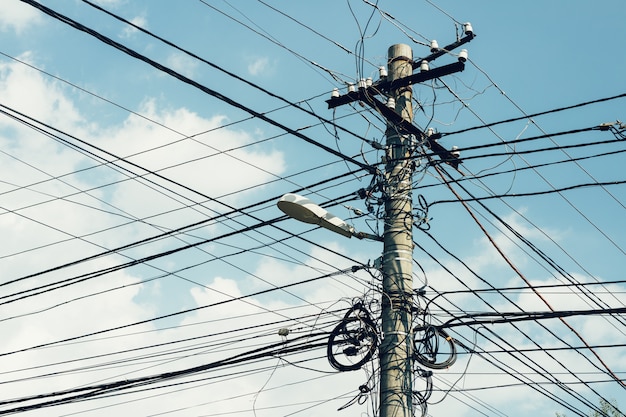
[326,28,474,417]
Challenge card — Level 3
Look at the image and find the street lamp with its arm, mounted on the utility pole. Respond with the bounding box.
[277,193,382,241]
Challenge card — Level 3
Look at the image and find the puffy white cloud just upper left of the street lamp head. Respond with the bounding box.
[91,100,285,231]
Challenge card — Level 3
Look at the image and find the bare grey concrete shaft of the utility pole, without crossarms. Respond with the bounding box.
[380,44,413,417]
